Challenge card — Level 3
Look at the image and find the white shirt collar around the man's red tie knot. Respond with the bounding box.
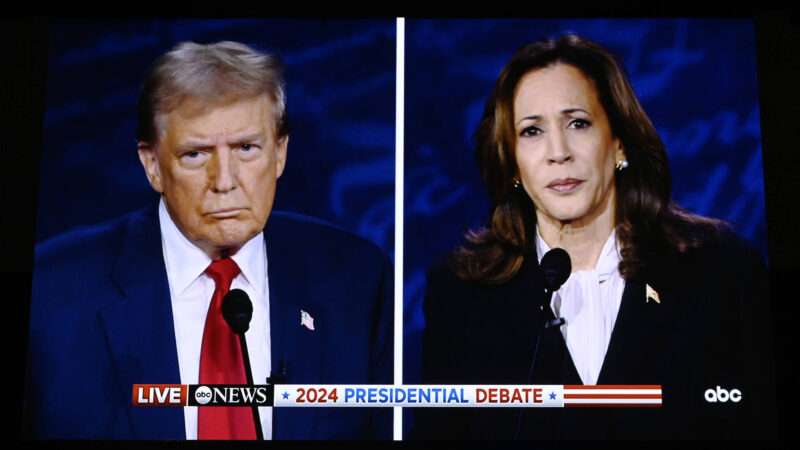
[158,197,267,295]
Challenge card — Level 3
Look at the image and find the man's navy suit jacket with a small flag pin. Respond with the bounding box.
[25,204,393,439]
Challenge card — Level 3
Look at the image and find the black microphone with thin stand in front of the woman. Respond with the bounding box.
[514,248,572,440]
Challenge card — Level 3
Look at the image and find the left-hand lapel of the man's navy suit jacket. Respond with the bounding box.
[100,206,186,439]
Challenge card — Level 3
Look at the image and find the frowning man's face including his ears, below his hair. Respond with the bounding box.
[139,96,289,259]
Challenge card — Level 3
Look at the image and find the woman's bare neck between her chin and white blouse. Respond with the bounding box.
[536,192,615,272]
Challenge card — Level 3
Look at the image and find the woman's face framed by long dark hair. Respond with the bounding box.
[514,63,624,229]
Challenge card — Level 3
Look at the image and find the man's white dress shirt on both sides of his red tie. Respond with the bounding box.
[158,197,272,439]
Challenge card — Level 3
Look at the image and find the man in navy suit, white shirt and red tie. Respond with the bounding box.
[25,42,393,439]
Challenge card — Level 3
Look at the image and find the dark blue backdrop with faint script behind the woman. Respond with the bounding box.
[403,19,767,429]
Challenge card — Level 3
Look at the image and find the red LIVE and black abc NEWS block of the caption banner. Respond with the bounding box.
[133,384,273,407]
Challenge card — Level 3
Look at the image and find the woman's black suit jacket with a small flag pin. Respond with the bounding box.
[413,233,777,439]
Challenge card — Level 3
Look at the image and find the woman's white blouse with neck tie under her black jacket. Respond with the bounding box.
[536,228,625,384]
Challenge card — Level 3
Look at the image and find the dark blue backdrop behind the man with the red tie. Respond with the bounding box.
[36,19,395,255]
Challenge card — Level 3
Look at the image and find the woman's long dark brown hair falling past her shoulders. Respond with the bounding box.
[452,35,724,283]
